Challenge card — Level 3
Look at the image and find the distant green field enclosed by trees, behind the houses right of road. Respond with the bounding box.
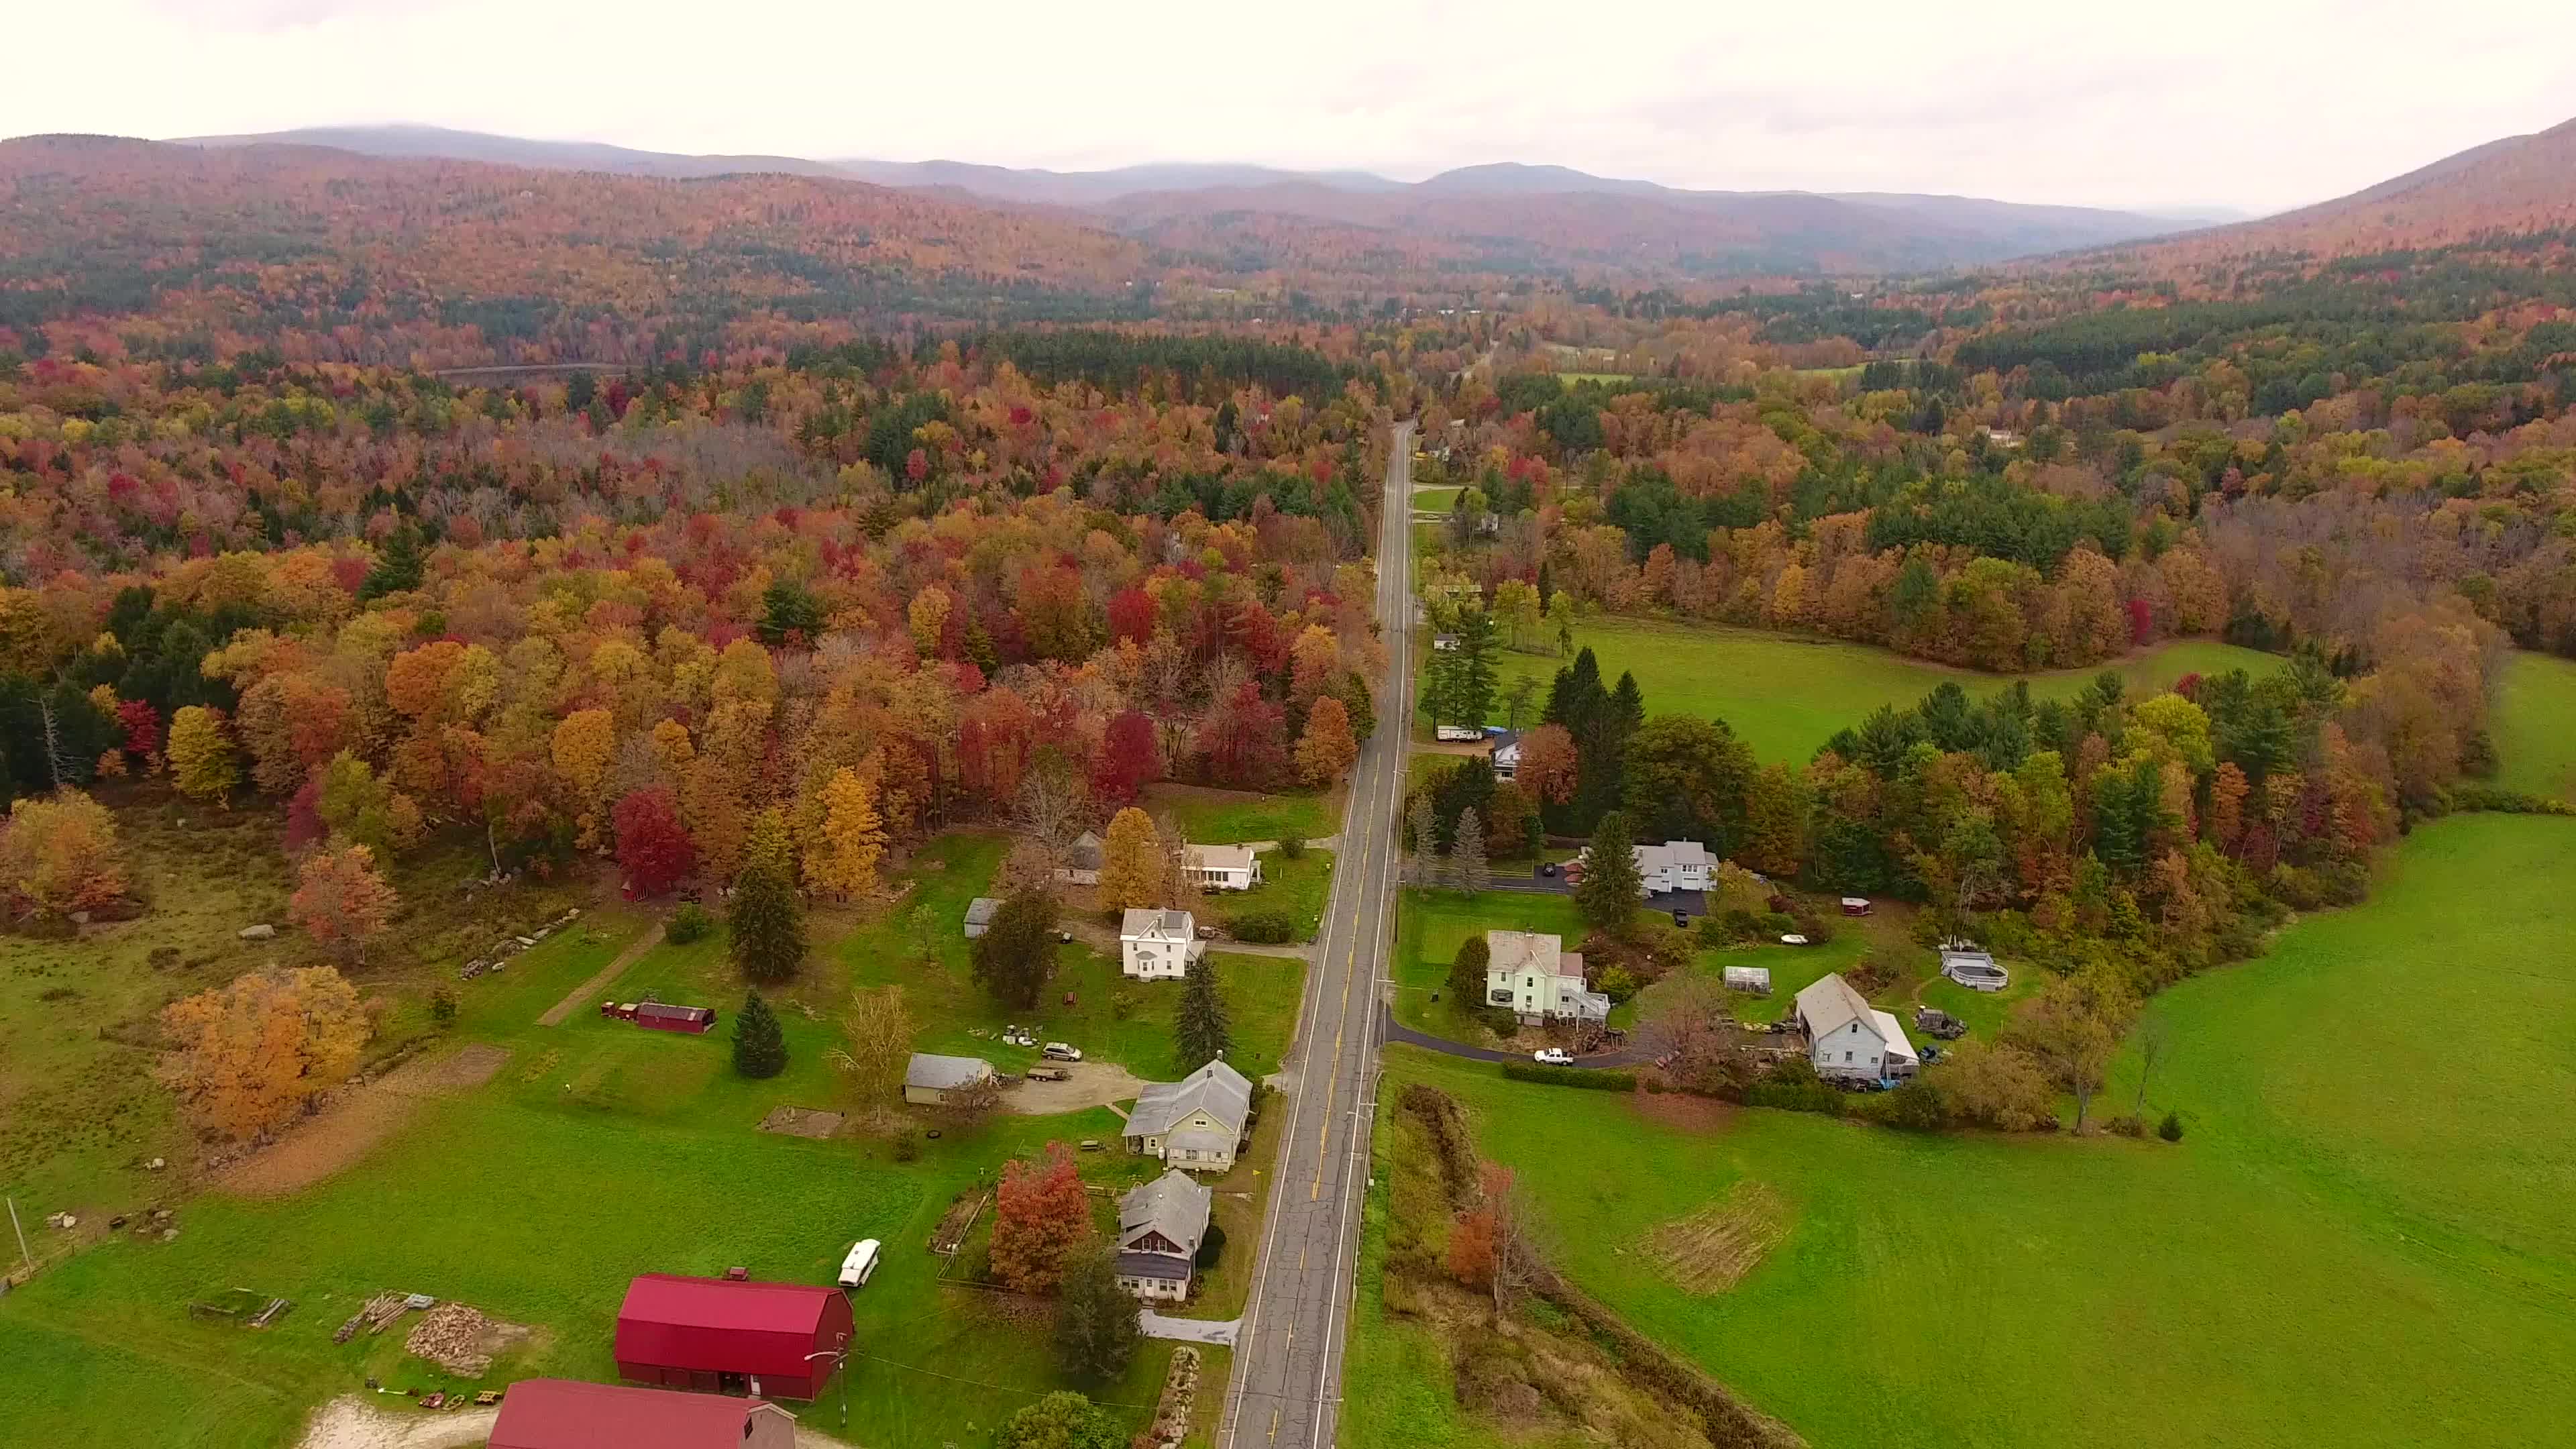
[1414,619,2277,761]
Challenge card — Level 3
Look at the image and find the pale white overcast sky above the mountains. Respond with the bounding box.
[0,0,2576,211]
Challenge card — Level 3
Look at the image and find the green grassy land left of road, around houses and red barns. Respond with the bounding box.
[0,835,1301,1449]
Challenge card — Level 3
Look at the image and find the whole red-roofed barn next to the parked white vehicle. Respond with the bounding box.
[619,1274,853,1400]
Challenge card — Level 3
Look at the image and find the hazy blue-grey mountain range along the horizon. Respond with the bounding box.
[171,126,2205,276]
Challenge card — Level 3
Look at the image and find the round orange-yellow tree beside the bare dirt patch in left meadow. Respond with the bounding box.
[157,967,368,1137]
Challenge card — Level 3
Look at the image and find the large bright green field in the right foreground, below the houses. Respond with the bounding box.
[1350,817,2576,1449]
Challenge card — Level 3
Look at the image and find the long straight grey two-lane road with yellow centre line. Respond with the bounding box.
[1218,423,1414,1449]
